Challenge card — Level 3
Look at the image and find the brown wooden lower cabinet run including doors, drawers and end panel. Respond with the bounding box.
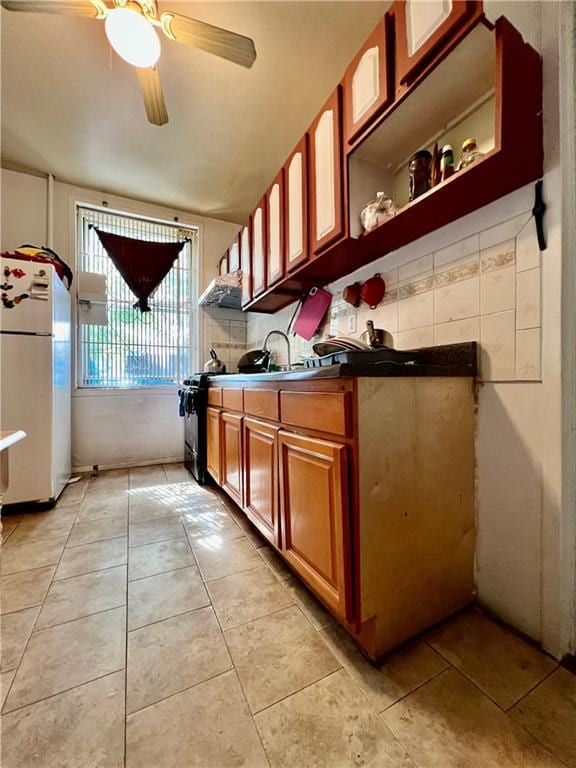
[208,376,476,660]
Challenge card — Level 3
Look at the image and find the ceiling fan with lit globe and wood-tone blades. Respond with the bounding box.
[0,0,256,125]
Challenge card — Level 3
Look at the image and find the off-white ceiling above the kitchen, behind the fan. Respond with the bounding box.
[1,0,389,223]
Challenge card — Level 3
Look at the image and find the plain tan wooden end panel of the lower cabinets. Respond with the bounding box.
[358,378,475,655]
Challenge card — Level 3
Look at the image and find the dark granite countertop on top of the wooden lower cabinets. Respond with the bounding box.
[210,341,477,384]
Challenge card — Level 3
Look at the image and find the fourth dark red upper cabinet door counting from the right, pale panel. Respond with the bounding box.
[284,133,309,272]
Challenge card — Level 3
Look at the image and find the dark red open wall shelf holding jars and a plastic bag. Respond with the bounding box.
[245,12,543,312]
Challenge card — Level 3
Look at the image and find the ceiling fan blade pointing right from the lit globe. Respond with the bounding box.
[160,12,256,68]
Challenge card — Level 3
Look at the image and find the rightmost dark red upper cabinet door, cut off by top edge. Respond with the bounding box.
[391,0,482,86]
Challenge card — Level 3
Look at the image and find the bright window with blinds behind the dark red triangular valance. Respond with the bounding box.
[77,206,198,388]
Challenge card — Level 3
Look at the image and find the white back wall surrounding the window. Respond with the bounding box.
[1,170,238,470]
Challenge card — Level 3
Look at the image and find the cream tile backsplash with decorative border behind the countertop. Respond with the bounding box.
[245,211,541,381]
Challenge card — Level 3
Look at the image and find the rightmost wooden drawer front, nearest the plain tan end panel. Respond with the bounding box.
[280,392,352,435]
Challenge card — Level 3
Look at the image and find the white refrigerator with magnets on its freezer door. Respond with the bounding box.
[0,258,71,504]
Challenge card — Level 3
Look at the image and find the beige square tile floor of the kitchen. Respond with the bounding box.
[1,465,576,768]
